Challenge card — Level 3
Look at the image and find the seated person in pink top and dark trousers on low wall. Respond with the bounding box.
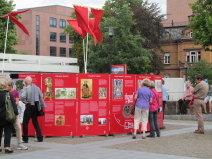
[178,81,194,114]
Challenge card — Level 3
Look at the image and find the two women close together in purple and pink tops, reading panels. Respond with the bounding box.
[132,79,160,139]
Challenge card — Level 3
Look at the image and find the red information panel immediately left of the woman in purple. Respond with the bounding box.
[110,75,135,134]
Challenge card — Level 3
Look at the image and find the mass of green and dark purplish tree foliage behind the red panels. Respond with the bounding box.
[65,0,163,74]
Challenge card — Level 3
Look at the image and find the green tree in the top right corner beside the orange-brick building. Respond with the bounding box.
[189,0,212,51]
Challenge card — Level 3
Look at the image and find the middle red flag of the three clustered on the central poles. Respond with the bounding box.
[74,5,96,45]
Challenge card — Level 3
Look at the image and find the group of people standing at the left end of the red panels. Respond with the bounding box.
[0,76,45,153]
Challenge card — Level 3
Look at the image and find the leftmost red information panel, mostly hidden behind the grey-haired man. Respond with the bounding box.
[17,73,43,136]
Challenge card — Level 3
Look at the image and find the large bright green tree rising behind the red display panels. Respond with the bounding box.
[88,3,151,74]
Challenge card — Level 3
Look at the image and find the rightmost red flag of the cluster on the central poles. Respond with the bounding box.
[91,8,104,43]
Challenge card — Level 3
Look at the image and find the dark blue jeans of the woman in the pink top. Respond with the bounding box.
[149,111,160,136]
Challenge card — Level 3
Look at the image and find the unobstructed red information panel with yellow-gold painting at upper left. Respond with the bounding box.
[77,74,110,136]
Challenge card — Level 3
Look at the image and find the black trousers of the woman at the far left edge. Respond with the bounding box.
[0,123,12,147]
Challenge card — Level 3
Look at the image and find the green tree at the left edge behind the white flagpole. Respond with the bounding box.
[0,0,18,53]
